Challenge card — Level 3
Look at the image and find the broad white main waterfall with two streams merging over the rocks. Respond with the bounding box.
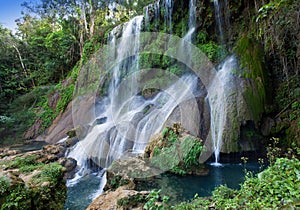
[68,0,198,184]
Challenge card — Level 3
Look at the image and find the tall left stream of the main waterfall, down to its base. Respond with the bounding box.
[68,16,143,178]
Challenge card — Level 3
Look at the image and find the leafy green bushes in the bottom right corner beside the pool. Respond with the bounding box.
[174,158,300,210]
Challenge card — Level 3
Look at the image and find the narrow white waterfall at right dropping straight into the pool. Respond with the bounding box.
[208,56,237,166]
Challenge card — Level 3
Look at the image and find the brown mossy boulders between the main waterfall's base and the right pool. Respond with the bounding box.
[88,124,208,210]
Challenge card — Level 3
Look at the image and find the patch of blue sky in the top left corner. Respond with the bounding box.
[0,0,25,31]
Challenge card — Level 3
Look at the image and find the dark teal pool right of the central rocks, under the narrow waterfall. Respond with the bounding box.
[138,162,259,203]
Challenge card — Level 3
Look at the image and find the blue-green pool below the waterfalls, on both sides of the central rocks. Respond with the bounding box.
[64,162,259,210]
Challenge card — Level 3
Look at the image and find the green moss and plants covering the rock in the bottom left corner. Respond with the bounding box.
[0,155,66,210]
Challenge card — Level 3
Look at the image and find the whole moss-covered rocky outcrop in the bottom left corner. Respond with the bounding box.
[0,145,76,210]
